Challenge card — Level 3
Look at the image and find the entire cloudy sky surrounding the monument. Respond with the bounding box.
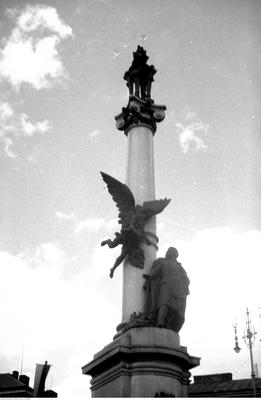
[0,0,261,399]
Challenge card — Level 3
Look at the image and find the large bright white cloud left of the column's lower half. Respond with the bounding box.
[0,243,120,396]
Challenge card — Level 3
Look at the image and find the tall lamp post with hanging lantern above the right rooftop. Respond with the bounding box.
[234,308,257,397]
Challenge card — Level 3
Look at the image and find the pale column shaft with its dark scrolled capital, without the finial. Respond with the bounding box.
[115,95,166,323]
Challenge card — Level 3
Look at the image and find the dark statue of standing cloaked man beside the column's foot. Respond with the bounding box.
[143,247,189,332]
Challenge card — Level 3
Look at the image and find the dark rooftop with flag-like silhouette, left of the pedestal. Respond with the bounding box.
[0,362,57,398]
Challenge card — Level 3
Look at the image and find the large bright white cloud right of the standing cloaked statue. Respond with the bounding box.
[158,227,261,377]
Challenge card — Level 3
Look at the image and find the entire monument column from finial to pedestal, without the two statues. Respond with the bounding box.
[82,46,199,398]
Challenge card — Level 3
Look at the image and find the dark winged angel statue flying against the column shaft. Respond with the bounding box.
[101,172,170,278]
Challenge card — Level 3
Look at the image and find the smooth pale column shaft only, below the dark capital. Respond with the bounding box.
[122,124,157,322]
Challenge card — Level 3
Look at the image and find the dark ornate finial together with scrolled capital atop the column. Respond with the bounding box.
[115,46,166,135]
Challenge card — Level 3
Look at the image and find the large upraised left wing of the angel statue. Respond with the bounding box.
[101,172,135,225]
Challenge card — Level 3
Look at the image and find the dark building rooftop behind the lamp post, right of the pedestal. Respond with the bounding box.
[189,373,261,397]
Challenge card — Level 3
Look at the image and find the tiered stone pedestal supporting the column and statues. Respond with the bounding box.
[82,327,200,397]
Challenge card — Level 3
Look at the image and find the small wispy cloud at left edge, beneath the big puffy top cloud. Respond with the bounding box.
[0,101,52,158]
